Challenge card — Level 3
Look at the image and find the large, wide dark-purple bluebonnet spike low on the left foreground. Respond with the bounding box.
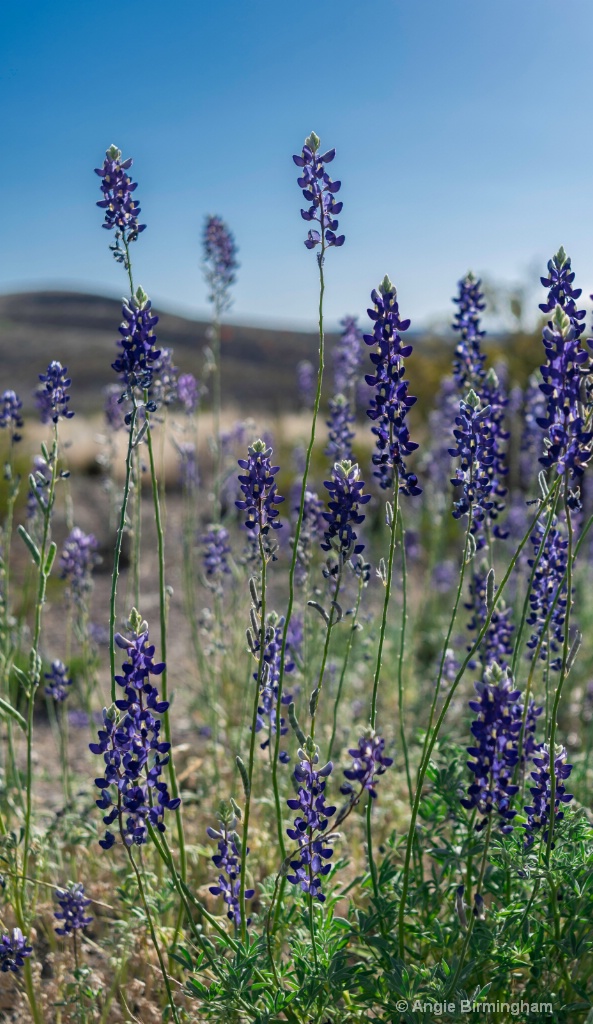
[90,612,180,850]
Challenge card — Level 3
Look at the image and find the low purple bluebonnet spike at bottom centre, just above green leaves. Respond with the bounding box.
[287,737,336,903]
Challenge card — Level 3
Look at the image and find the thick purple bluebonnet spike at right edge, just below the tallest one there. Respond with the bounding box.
[538,305,593,501]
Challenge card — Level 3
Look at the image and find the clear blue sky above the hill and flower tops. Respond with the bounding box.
[0,0,593,326]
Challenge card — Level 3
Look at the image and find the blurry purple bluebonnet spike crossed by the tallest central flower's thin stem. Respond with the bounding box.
[251,611,295,764]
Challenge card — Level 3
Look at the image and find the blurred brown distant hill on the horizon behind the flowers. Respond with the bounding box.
[0,292,335,413]
